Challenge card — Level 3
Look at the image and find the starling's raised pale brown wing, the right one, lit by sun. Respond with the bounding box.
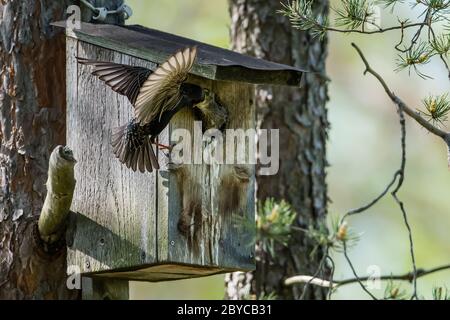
[134,47,197,124]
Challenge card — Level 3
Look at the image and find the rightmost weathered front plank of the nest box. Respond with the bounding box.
[211,81,256,270]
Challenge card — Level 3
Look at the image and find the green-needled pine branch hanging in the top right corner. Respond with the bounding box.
[278,0,450,79]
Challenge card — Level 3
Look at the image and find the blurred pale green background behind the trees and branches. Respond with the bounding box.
[126,0,450,299]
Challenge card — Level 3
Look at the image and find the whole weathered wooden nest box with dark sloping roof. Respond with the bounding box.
[56,23,302,281]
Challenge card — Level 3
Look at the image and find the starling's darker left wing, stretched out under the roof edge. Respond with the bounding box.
[77,57,152,105]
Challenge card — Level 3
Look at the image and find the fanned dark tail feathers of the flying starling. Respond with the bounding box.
[111,121,159,172]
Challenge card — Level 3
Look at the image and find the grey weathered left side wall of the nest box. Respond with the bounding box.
[67,42,156,273]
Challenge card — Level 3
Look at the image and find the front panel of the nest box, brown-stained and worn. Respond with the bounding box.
[158,76,255,271]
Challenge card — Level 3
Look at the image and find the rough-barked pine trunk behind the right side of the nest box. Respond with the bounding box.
[226,0,328,299]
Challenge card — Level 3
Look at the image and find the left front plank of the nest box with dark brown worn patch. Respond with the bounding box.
[163,77,217,266]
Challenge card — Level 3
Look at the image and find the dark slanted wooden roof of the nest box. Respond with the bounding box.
[53,21,304,86]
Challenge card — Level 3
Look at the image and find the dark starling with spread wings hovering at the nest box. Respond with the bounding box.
[77,47,205,172]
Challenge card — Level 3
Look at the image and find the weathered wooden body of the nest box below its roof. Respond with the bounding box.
[67,38,255,281]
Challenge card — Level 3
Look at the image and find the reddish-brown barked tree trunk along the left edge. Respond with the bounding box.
[0,0,123,299]
